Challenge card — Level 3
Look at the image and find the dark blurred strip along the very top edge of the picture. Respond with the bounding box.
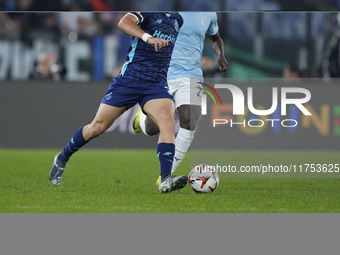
[0,0,340,11]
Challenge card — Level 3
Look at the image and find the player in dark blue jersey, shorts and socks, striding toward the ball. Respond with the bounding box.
[49,12,188,193]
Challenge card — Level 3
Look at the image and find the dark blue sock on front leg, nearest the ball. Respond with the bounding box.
[157,143,175,181]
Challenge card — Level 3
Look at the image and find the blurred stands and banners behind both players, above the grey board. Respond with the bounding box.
[0,5,340,81]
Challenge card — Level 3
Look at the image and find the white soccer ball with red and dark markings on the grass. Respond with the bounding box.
[189,164,219,193]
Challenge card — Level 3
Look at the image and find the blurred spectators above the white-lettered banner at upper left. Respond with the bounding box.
[0,12,124,38]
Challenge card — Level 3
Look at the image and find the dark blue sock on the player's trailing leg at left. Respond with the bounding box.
[58,127,87,164]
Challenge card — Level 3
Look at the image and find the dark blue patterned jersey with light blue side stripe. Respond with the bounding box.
[119,12,183,83]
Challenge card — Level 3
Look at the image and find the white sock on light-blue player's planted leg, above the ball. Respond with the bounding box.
[171,127,195,174]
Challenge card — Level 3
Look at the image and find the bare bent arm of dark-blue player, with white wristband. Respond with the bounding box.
[118,14,169,51]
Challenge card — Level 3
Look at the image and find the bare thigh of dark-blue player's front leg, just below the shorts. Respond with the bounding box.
[143,98,175,128]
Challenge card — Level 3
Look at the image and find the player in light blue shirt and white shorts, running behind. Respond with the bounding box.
[133,12,228,184]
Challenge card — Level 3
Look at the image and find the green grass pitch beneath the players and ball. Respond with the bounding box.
[0,149,340,213]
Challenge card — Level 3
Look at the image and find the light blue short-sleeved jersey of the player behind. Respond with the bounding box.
[168,12,218,80]
